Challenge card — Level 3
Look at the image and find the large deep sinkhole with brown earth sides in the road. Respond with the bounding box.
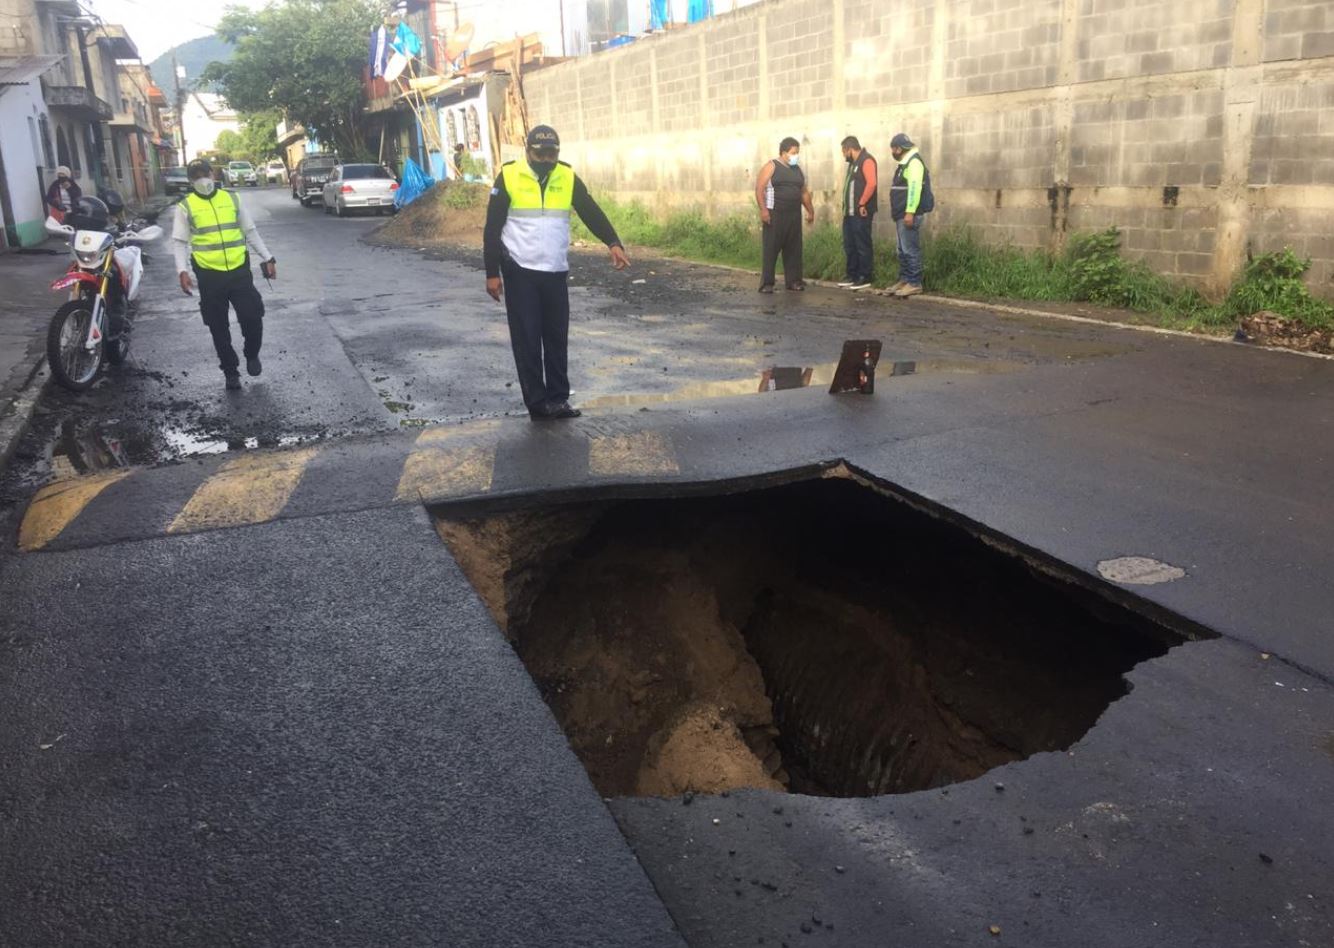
[434,465,1213,796]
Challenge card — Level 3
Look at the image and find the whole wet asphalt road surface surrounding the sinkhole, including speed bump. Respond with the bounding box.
[0,191,1334,948]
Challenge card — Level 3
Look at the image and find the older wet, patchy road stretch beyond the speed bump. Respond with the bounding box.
[3,188,1145,512]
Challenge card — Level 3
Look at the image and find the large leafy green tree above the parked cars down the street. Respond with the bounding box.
[201,0,382,159]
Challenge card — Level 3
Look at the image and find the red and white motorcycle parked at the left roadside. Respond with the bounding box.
[47,217,163,392]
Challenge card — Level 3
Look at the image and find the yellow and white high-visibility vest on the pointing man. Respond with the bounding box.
[500,161,575,273]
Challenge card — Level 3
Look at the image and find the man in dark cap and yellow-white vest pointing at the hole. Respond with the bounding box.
[483,125,630,420]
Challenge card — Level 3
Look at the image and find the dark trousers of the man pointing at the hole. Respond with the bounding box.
[500,260,570,411]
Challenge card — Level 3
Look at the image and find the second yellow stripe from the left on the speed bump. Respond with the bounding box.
[167,448,316,533]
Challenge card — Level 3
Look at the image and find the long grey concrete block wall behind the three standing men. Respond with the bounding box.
[524,0,1334,296]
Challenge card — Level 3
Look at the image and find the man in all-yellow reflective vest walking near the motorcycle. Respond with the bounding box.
[172,159,277,391]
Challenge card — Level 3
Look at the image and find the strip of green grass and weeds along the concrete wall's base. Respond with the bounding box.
[574,199,1334,335]
